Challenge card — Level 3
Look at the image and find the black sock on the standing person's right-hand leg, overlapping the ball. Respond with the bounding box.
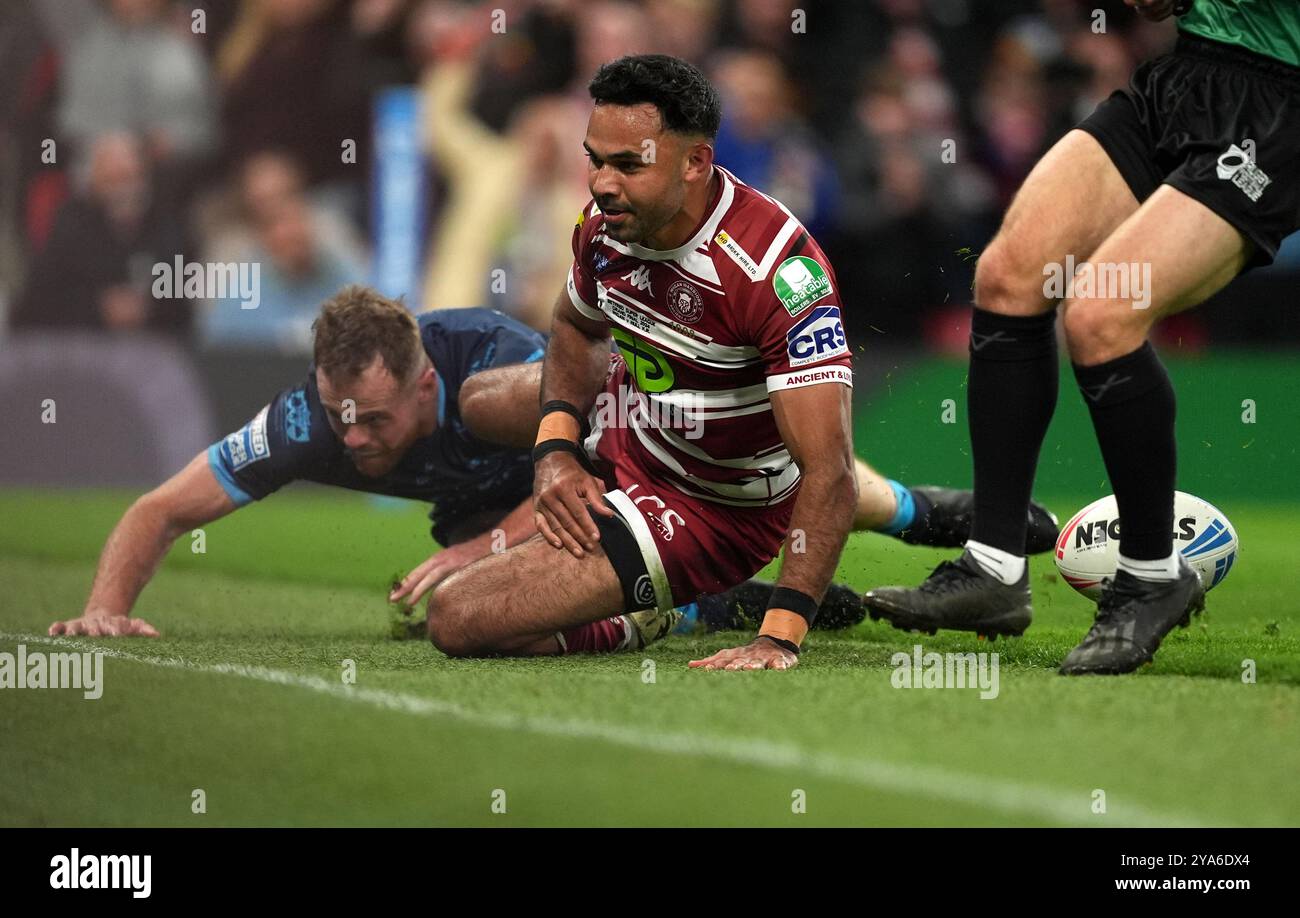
[1074,342,1178,560]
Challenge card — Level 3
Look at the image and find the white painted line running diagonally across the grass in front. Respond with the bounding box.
[0,632,1200,827]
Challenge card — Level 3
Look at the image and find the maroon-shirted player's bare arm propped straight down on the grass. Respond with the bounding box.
[690,384,858,670]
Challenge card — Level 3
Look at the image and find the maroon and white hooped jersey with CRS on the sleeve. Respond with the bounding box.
[568,166,853,507]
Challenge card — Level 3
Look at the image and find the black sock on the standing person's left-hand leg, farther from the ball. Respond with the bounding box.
[966,308,1058,555]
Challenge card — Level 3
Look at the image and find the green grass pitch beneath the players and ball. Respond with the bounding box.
[0,488,1300,826]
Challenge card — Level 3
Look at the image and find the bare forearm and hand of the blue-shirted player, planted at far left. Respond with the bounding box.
[49,452,235,637]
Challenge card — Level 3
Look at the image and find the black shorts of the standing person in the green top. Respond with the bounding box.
[1079,34,1300,267]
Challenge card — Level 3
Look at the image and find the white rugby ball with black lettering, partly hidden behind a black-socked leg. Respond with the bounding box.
[1056,492,1238,599]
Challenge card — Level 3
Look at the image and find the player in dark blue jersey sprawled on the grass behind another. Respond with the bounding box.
[49,286,1056,648]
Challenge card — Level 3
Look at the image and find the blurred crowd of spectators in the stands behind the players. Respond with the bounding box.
[0,0,1300,351]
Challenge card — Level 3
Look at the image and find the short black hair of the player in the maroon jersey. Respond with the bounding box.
[588,55,723,139]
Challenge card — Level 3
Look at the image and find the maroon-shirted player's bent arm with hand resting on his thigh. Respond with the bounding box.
[533,291,614,558]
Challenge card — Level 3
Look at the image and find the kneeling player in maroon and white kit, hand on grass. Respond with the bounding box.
[428,55,1055,670]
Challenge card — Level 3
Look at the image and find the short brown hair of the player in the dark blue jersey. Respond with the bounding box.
[312,285,424,382]
